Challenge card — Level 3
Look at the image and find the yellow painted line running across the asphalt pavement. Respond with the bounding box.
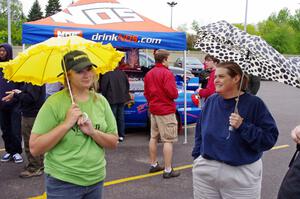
[25,144,289,199]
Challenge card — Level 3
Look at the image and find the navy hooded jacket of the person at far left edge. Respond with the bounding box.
[0,44,19,109]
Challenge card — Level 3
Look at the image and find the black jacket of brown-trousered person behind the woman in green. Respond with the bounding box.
[14,83,46,117]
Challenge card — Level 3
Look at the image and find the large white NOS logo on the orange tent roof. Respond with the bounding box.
[51,3,144,25]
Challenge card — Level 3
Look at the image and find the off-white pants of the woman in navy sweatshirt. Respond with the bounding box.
[193,156,262,199]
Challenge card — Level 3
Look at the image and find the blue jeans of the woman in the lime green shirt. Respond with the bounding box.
[46,174,103,199]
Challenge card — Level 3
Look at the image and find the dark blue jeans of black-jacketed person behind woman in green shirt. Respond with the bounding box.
[110,103,125,137]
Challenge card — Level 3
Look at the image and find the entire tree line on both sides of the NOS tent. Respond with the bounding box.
[0,0,300,54]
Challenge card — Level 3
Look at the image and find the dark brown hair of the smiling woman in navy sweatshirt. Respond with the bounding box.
[217,61,248,91]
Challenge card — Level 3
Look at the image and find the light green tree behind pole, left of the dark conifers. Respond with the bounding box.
[0,0,26,45]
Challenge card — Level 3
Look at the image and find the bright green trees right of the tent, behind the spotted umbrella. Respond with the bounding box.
[178,8,300,55]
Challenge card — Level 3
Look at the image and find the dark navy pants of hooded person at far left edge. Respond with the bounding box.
[0,107,22,155]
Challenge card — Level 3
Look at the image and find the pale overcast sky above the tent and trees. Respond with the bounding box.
[20,0,300,28]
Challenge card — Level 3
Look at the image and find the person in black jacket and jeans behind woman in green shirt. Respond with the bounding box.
[100,61,130,142]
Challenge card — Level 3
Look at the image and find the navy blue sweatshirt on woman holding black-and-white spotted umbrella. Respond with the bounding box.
[192,93,278,166]
